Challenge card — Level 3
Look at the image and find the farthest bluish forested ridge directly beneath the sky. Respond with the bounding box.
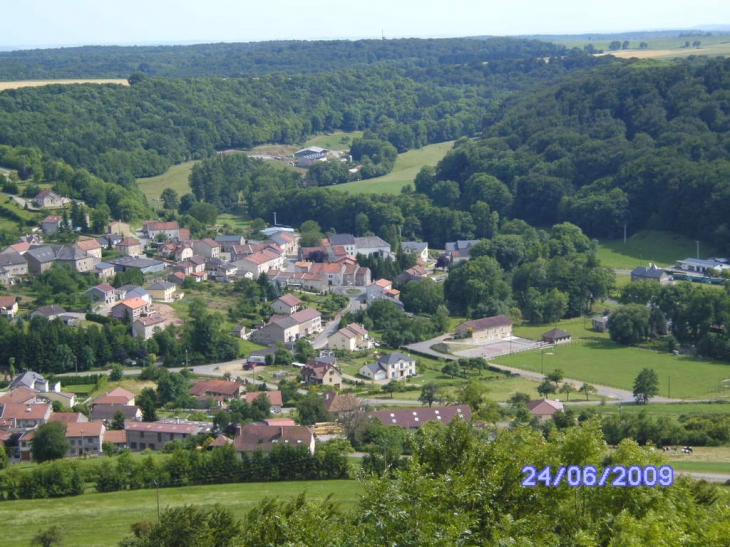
[0,38,567,81]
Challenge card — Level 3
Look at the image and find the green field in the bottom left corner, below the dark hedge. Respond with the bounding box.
[0,481,362,547]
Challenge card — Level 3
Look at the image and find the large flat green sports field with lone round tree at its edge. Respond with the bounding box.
[494,336,730,399]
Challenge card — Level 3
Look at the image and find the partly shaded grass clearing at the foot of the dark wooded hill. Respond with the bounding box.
[598,230,715,270]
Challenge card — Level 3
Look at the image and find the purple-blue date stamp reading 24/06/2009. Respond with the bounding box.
[522,465,674,487]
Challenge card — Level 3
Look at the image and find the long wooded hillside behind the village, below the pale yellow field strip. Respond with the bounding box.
[0,56,607,181]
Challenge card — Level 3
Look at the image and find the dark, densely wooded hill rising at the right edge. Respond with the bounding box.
[416,58,730,248]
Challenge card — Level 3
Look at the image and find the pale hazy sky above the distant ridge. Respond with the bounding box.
[0,0,730,48]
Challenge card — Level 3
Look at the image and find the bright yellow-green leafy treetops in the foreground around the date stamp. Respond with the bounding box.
[120,420,730,547]
